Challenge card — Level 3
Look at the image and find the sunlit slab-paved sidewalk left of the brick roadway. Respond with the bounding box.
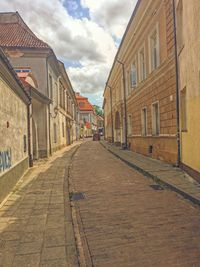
[0,145,81,267]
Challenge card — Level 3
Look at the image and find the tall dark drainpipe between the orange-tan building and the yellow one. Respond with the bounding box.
[173,0,181,166]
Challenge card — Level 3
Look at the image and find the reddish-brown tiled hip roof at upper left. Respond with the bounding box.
[0,13,50,48]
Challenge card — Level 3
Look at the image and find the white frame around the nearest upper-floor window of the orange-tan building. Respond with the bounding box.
[149,23,160,73]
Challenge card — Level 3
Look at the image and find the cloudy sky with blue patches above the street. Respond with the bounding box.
[0,0,137,105]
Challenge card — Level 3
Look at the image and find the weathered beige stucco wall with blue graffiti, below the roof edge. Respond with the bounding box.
[0,77,28,202]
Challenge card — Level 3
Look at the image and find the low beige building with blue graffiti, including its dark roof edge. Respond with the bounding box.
[0,49,30,202]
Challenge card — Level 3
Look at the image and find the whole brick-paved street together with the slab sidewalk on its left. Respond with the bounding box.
[0,141,200,267]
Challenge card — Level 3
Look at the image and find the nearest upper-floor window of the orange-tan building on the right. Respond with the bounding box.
[150,29,159,71]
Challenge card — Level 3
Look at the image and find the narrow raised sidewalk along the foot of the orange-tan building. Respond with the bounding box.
[101,141,200,205]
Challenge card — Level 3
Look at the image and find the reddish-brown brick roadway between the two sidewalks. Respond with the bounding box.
[71,142,200,267]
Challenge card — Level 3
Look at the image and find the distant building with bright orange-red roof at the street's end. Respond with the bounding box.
[76,93,97,137]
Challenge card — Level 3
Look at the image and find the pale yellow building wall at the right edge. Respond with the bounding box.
[175,0,200,180]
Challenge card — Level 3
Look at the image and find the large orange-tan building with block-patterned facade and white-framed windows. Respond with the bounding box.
[104,0,178,164]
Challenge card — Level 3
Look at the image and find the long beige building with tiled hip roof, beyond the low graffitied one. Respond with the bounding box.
[0,12,79,159]
